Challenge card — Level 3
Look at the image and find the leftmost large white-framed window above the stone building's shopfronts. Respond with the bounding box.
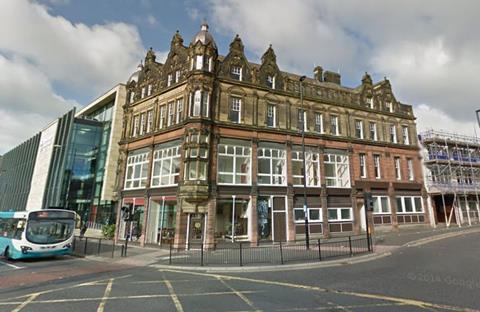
[125,150,150,190]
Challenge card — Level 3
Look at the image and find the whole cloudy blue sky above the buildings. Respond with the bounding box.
[0,0,480,154]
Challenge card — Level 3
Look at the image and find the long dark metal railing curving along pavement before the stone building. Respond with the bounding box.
[168,236,373,266]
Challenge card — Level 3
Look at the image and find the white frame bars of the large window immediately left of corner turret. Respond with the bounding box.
[150,146,181,187]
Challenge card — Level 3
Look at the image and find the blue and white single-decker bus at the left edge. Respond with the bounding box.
[0,209,77,259]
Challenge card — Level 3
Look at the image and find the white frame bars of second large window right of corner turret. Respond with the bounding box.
[257,147,287,186]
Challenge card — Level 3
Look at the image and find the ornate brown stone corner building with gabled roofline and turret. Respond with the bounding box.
[117,24,428,248]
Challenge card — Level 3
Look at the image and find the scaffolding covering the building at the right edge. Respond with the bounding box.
[419,130,480,227]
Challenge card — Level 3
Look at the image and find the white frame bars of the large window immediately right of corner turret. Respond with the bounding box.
[217,144,252,185]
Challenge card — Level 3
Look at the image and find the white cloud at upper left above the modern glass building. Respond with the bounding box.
[0,0,145,153]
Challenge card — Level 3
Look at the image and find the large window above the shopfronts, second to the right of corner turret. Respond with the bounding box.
[257,144,287,185]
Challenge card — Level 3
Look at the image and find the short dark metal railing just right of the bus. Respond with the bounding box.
[73,236,124,258]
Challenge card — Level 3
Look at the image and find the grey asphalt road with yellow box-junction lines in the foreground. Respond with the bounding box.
[0,233,480,312]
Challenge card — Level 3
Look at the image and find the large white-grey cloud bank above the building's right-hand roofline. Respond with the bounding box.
[210,0,480,133]
